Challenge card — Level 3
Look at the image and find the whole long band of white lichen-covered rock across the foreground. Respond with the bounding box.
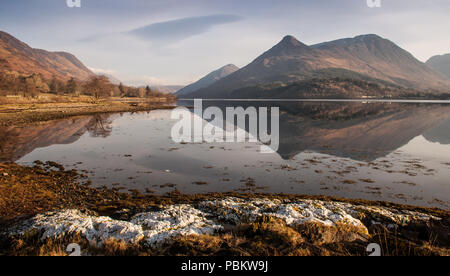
[6,197,439,247]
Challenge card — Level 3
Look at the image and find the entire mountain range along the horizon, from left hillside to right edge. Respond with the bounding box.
[0,31,450,99]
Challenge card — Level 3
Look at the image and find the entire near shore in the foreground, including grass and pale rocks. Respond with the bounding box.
[0,162,450,256]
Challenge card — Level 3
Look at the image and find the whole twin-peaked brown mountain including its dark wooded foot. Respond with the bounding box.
[183,34,450,98]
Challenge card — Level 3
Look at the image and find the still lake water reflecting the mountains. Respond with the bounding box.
[0,101,450,210]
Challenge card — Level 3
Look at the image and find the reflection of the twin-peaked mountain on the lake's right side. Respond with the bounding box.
[179,101,450,161]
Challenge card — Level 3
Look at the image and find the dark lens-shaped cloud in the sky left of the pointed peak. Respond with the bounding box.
[127,14,243,42]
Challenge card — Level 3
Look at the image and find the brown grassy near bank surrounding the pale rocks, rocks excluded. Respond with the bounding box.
[0,162,450,256]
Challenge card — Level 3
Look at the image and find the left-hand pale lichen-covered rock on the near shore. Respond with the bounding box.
[9,205,222,247]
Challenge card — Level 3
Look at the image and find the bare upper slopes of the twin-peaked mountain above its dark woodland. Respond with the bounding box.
[187,34,450,98]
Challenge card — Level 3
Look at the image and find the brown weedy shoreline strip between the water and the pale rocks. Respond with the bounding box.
[0,161,450,223]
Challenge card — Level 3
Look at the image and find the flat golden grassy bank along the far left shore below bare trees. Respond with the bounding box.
[0,96,173,126]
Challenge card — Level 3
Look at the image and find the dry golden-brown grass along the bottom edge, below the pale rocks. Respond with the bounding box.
[0,203,450,256]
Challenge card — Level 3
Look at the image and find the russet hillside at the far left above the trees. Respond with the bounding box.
[0,31,95,80]
